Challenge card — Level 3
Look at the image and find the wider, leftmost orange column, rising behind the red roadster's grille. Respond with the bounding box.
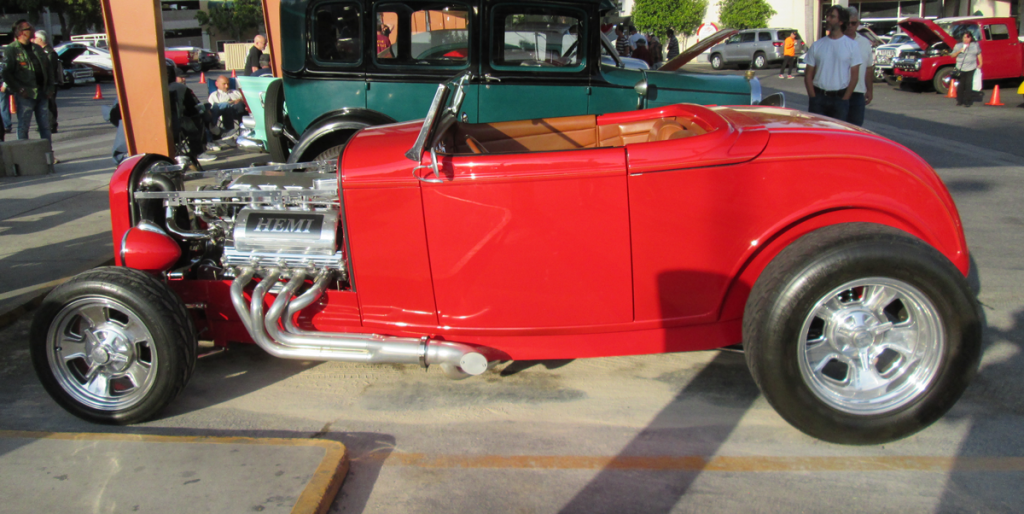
[100,0,174,157]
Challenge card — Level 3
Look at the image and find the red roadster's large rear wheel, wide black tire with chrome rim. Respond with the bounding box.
[743,223,982,444]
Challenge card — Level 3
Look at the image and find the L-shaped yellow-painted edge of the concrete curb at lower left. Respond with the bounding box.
[0,430,348,514]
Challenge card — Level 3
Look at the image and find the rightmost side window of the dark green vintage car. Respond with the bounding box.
[490,4,586,72]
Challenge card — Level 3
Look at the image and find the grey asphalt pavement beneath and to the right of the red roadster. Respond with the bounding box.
[0,67,1024,513]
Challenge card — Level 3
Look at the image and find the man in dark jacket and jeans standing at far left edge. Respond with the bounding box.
[3,19,53,139]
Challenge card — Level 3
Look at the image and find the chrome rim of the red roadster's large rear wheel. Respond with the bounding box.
[799,277,946,415]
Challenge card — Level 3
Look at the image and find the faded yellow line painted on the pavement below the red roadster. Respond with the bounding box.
[358,453,1024,473]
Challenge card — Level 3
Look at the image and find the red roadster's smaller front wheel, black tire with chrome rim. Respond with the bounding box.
[30,267,198,425]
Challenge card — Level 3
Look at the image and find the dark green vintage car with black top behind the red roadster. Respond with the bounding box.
[239,0,761,163]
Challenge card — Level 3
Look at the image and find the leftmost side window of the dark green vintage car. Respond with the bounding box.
[311,2,362,65]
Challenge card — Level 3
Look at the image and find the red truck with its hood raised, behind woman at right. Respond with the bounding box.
[893,16,1024,94]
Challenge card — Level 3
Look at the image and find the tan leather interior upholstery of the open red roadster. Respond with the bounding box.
[455,115,707,154]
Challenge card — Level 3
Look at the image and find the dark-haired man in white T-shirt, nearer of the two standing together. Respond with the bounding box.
[804,5,862,121]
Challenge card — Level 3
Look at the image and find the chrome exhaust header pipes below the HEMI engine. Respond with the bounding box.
[230,267,488,378]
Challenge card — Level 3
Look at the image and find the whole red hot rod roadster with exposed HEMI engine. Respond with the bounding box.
[31,77,981,443]
